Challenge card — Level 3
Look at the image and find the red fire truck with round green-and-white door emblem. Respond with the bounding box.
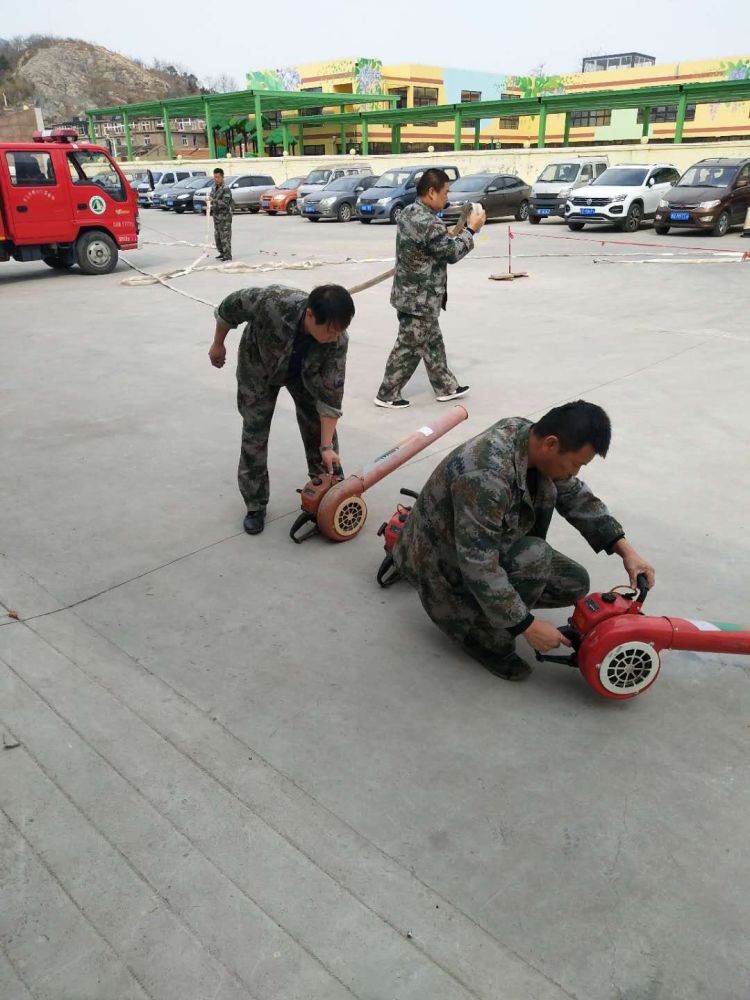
[0,129,140,274]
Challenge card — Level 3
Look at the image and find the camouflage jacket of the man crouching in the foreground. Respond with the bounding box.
[394,417,624,631]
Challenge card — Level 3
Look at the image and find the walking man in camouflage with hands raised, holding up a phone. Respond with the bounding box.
[374,167,486,409]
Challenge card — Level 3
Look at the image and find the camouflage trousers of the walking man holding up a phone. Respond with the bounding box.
[378,312,458,400]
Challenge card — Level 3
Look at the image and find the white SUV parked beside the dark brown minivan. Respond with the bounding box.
[565,163,680,233]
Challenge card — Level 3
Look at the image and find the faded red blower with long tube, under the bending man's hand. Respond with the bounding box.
[289,405,469,543]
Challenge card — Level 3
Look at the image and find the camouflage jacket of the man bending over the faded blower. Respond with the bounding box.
[214,285,349,417]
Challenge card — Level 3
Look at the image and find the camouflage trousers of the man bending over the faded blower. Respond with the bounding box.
[237,368,339,510]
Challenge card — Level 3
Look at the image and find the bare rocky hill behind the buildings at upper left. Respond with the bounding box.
[0,36,204,123]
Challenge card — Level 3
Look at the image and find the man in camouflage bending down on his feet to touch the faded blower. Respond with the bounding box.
[208,285,354,535]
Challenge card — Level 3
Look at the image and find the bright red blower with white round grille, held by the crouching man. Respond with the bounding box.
[536,575,750,699]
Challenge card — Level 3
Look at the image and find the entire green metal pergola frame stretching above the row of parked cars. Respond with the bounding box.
[86,79,750,159]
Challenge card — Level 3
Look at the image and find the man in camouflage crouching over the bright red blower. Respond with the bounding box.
[393,400,654,680]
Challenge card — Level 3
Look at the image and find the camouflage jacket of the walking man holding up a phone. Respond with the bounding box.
[391,198,474,319]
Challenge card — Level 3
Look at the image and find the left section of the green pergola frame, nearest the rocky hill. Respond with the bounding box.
[86,90,398,160]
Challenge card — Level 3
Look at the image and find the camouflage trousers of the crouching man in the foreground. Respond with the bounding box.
[408,535,589,656]
